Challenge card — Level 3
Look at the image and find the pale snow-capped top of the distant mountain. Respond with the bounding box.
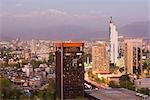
[13,9,100,20]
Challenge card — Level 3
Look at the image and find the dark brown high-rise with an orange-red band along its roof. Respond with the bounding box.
[55,42,84,100]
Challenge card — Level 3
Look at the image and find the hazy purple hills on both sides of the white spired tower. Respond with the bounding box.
[1,21,150,40]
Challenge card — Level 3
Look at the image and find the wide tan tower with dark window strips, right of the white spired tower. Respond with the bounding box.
[124,39,142,74]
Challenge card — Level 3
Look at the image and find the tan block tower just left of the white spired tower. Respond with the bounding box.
[92,42,109,73]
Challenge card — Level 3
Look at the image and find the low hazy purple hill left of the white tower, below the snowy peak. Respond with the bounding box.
[2,25,108,40]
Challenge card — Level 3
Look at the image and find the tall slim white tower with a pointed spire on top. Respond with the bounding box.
[109,17,118,64]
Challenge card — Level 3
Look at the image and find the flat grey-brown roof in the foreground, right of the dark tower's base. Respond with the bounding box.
[86,88,145,100]
